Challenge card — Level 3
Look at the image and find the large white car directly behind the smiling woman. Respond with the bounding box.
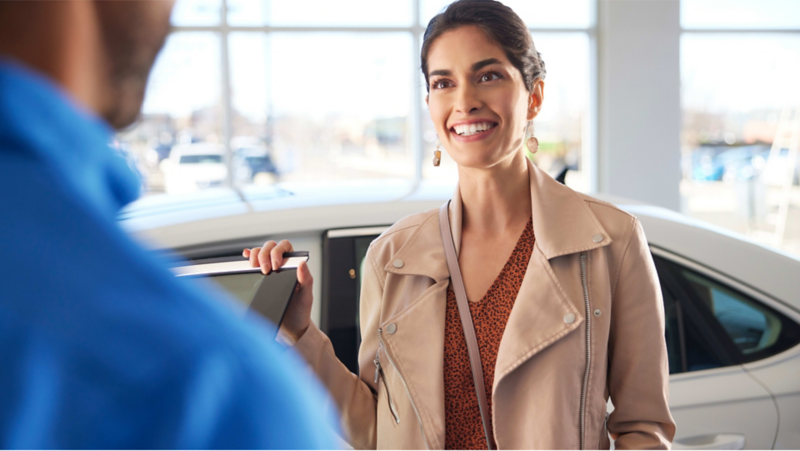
[121,181,800,449]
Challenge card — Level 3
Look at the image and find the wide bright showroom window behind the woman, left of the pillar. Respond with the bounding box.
[115,0,595,198]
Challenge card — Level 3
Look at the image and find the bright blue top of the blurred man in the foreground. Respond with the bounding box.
[0,60,337,449]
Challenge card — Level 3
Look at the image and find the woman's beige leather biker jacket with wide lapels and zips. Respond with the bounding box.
[295,164,675,449]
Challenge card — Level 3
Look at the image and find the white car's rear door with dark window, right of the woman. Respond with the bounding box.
[653,248,800,449]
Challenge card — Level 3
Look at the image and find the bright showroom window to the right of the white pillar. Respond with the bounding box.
[681,0,800,255]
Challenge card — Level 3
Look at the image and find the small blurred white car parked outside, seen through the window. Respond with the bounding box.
[161,143,228,194]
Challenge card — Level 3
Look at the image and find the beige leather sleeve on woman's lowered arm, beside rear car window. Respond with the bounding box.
[608,219,675,449]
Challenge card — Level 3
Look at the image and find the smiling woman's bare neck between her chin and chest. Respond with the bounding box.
[458,151,531,235]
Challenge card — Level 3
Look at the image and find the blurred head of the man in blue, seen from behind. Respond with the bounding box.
[0,0,174,129]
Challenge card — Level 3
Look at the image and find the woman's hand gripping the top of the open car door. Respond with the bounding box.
[242,240,314,343]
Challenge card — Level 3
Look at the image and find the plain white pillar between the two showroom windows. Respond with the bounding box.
[596,0,681,210]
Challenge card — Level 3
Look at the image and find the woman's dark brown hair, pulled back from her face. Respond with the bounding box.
[420,0,547,92]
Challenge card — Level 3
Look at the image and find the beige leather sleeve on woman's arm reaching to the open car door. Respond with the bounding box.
[294,245,383,449]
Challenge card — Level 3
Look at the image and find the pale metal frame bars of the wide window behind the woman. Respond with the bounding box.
[171,0,599,191]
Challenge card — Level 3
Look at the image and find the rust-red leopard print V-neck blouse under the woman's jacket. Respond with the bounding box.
[444,218,535,449]
